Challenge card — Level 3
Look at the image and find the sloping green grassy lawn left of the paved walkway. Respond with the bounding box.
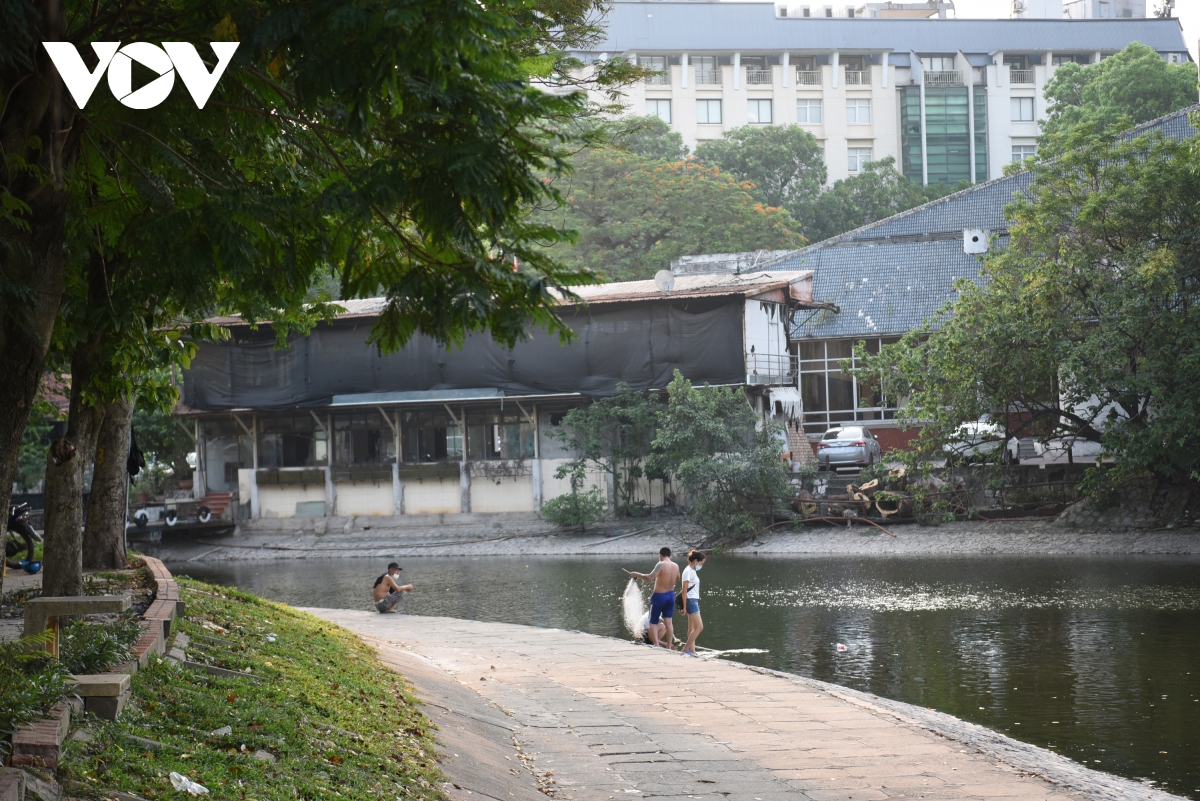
[64,579,444,800]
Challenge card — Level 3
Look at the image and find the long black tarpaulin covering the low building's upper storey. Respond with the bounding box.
[184,296,745,411]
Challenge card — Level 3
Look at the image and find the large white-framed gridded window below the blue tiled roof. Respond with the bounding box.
[799,337,899,434]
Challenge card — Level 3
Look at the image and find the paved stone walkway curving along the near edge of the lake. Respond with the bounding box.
[308,609,1176,801]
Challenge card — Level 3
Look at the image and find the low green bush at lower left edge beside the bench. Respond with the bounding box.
[0,632,67,754]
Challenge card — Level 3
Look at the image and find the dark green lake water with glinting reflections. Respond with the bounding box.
[182,555,1200,800]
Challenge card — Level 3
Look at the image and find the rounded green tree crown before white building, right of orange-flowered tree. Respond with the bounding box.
[696,125,828,209]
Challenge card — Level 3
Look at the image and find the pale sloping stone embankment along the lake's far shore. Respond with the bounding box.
[157,516,1200,565]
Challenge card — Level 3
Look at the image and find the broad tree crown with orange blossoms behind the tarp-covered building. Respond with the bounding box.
[536,147,805,281]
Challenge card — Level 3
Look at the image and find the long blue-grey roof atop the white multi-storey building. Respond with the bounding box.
[592,2,1188,53]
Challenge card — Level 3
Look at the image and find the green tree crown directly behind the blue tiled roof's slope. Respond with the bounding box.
[793,156,958,242]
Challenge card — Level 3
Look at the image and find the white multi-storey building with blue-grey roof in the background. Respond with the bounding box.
[581,0,1189,183]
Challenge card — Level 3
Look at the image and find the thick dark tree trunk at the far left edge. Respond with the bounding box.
[0,0,79,599]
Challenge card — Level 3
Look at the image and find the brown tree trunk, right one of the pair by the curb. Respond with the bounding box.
[83,399,133,568]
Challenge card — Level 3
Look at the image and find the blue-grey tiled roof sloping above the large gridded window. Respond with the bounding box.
[766,106,1200,339]
